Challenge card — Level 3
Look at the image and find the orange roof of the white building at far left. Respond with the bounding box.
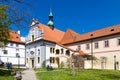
[9,30,23,43]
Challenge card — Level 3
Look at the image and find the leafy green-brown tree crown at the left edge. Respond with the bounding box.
[0,5,11,47]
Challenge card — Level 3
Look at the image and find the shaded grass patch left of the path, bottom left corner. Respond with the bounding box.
[0,70,14,80]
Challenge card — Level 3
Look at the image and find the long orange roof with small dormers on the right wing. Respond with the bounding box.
[62,25,120,44]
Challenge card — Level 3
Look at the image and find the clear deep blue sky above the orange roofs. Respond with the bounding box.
[11,0,120,36]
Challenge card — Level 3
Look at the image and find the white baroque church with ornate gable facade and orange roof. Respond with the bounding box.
[26,19,73,68]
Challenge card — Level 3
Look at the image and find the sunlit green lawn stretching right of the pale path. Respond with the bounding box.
[36,70,120,80]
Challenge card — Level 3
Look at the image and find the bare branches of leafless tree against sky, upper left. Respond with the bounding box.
[0,0,33,29]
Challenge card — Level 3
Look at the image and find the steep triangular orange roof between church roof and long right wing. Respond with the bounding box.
[60,29,80,44]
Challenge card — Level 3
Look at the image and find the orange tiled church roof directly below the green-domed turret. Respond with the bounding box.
[38,23,64,42]
